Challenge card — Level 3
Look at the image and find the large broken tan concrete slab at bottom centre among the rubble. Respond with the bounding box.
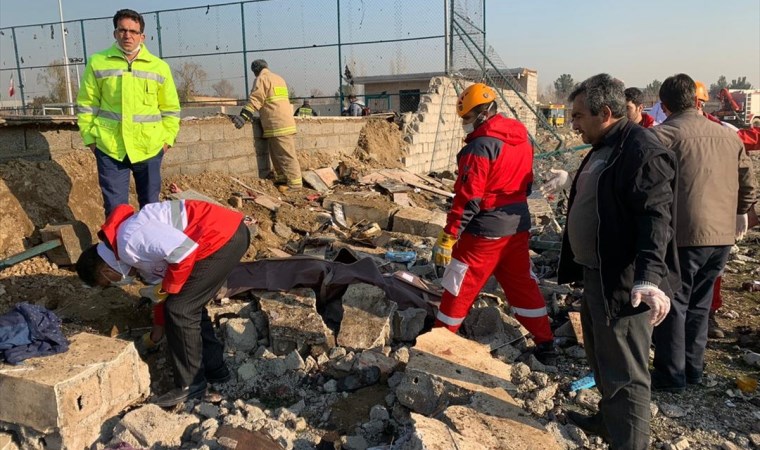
[396,328,561,450]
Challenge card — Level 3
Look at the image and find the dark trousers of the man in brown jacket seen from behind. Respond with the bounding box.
[653,246,731,387]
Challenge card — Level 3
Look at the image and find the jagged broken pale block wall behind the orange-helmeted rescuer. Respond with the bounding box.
[402,77,536,173]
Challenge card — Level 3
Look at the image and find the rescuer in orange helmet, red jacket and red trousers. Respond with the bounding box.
[433,83,556,364]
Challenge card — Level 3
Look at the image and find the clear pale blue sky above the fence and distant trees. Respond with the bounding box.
[0,0,760,100]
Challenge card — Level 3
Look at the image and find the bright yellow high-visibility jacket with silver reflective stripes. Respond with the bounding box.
[77,44,180,163]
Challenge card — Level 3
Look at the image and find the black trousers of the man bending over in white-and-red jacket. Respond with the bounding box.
[165,222,250,387]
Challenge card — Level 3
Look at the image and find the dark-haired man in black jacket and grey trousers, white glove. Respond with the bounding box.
[558,74,678,449]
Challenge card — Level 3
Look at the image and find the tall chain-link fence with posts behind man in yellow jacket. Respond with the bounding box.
[0,0,448,114]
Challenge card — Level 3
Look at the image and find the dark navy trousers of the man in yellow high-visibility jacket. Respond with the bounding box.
[95,150,164,217]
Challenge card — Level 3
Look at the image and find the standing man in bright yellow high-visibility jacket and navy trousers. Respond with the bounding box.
[77,9,180,216]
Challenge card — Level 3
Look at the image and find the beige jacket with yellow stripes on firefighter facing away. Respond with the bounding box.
[243,69,296,138]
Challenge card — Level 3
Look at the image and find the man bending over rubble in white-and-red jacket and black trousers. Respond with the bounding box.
[76,200,249,407]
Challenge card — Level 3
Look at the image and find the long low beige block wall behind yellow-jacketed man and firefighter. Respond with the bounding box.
[0,117,366,176]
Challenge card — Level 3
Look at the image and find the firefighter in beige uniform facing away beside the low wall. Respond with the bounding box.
[232,59,303,192]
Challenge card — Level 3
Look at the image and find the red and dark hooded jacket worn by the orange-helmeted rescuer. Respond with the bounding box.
[444,114,533,237]
